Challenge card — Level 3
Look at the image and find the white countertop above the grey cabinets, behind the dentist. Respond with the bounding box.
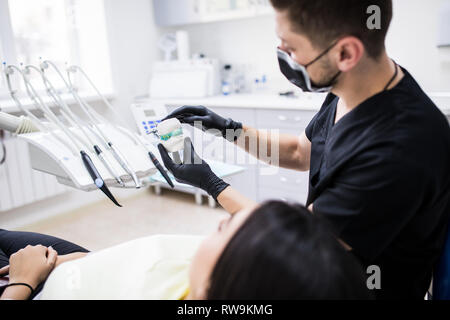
[143,93,450,116]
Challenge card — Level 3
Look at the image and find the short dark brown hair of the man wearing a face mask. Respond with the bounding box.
[270,0,392,59]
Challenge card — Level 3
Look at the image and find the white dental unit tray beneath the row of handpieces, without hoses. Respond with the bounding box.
[18,124,157,191]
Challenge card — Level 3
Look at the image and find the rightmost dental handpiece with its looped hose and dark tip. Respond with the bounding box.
[67,66,174,188]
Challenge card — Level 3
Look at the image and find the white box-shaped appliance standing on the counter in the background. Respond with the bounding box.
[150,58,220,98]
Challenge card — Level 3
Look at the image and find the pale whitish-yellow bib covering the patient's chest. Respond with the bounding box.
[41,235,204,300]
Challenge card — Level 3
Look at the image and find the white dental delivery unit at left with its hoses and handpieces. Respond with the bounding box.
[0,64,156,204]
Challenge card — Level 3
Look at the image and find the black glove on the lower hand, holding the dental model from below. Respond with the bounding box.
[158,138,229,200]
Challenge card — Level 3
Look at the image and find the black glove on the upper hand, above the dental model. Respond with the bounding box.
[163,106,242,142]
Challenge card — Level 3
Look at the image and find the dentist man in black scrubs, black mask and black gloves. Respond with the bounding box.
[160,0,450,299]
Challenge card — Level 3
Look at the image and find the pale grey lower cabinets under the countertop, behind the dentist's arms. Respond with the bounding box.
[166,104,317,203]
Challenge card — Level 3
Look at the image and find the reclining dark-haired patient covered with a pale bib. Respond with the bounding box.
[0,201,371,299]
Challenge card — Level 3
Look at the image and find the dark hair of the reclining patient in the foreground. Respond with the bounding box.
[207,201,371,300]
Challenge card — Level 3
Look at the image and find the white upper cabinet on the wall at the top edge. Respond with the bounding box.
[153,0,273,27]
